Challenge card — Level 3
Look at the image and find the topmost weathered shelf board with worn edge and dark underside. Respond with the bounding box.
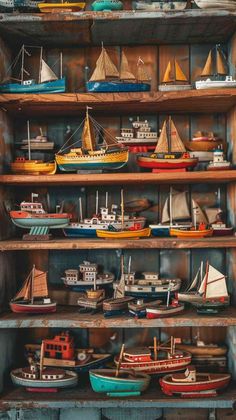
[0,9,236,48]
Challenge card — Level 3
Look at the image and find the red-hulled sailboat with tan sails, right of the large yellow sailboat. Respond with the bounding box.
[137,117,198,170]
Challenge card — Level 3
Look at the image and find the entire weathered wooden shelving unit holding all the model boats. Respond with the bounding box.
[0,2,236,418]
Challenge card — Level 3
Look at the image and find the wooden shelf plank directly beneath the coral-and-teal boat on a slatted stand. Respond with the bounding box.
[0,236,236,251]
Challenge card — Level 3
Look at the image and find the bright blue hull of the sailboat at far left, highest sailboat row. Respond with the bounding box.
[0,78,66,93]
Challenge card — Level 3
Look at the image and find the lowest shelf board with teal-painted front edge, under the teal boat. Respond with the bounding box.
[0,377,236,411]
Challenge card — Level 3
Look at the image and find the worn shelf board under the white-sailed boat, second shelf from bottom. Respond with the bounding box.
[0,306,236,329]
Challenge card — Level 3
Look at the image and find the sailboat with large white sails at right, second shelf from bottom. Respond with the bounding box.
[177,262,229,315]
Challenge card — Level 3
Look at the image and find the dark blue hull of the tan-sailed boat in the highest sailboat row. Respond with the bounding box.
[86,81,151,92]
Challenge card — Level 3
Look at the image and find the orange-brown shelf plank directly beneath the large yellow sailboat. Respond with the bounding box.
[0,170,236,186]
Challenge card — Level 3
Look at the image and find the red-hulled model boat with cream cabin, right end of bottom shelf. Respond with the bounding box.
[159,366,231,398]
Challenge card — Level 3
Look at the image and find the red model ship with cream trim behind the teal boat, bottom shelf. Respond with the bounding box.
[114,337,191,375]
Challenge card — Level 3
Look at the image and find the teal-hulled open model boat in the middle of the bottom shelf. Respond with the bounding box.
[89,369,151,397]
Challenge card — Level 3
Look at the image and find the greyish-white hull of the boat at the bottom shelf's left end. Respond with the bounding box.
[11,369,78,388]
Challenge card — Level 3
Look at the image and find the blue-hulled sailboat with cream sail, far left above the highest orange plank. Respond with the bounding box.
[0,45,65,93]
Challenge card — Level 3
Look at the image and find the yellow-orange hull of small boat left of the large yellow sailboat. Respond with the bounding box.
[11,160,57,175]
